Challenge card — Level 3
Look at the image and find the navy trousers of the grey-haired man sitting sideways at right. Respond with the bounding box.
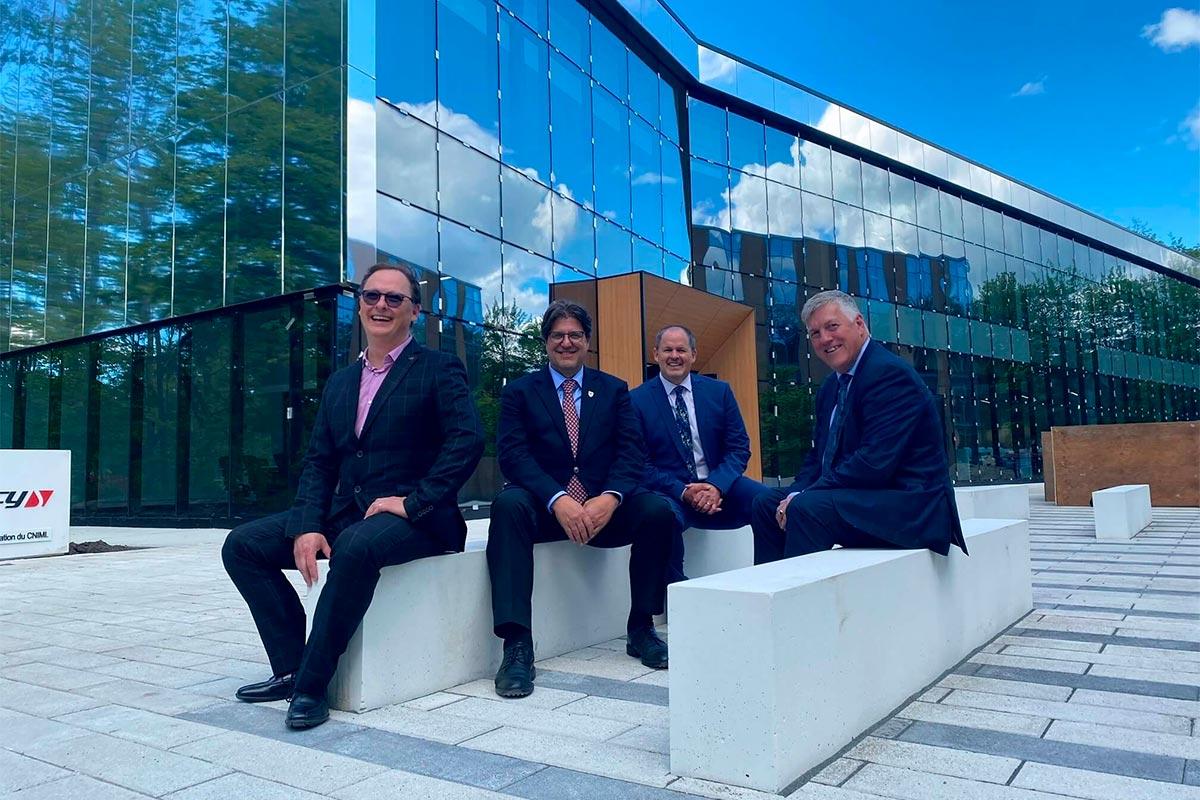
[750,489,896,564]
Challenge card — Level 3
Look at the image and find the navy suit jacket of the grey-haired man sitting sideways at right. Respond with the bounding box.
[788,339,966,555]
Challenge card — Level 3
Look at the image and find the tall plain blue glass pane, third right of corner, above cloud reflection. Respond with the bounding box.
[500,14,550,182]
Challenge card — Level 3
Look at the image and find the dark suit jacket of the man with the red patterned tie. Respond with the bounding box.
[496,367,644,506]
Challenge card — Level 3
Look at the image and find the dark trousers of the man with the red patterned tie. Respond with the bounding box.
[487,486,673,636]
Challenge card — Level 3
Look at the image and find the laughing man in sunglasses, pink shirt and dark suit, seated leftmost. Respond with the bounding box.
[222,263,484,729]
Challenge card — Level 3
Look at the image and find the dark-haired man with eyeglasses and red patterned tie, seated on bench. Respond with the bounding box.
[487,300,671,697]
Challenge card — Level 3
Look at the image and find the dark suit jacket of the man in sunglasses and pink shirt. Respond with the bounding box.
[287,341,484,551]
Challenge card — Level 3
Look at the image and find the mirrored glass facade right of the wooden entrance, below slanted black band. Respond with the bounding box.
[688,97,1200,483]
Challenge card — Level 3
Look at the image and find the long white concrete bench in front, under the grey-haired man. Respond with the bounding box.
[667,519,1033,793]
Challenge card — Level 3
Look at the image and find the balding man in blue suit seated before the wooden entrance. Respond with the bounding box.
[629,325,767,583]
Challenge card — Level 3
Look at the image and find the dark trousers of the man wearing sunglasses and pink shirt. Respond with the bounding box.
[221,509,444,696]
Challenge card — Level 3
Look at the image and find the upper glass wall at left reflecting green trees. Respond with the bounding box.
[0,0,344,355]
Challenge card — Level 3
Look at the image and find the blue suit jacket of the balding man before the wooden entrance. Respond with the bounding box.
[629,374,750,500]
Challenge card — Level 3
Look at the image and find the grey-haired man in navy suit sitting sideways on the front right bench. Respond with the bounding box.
[752,290,966,564]
